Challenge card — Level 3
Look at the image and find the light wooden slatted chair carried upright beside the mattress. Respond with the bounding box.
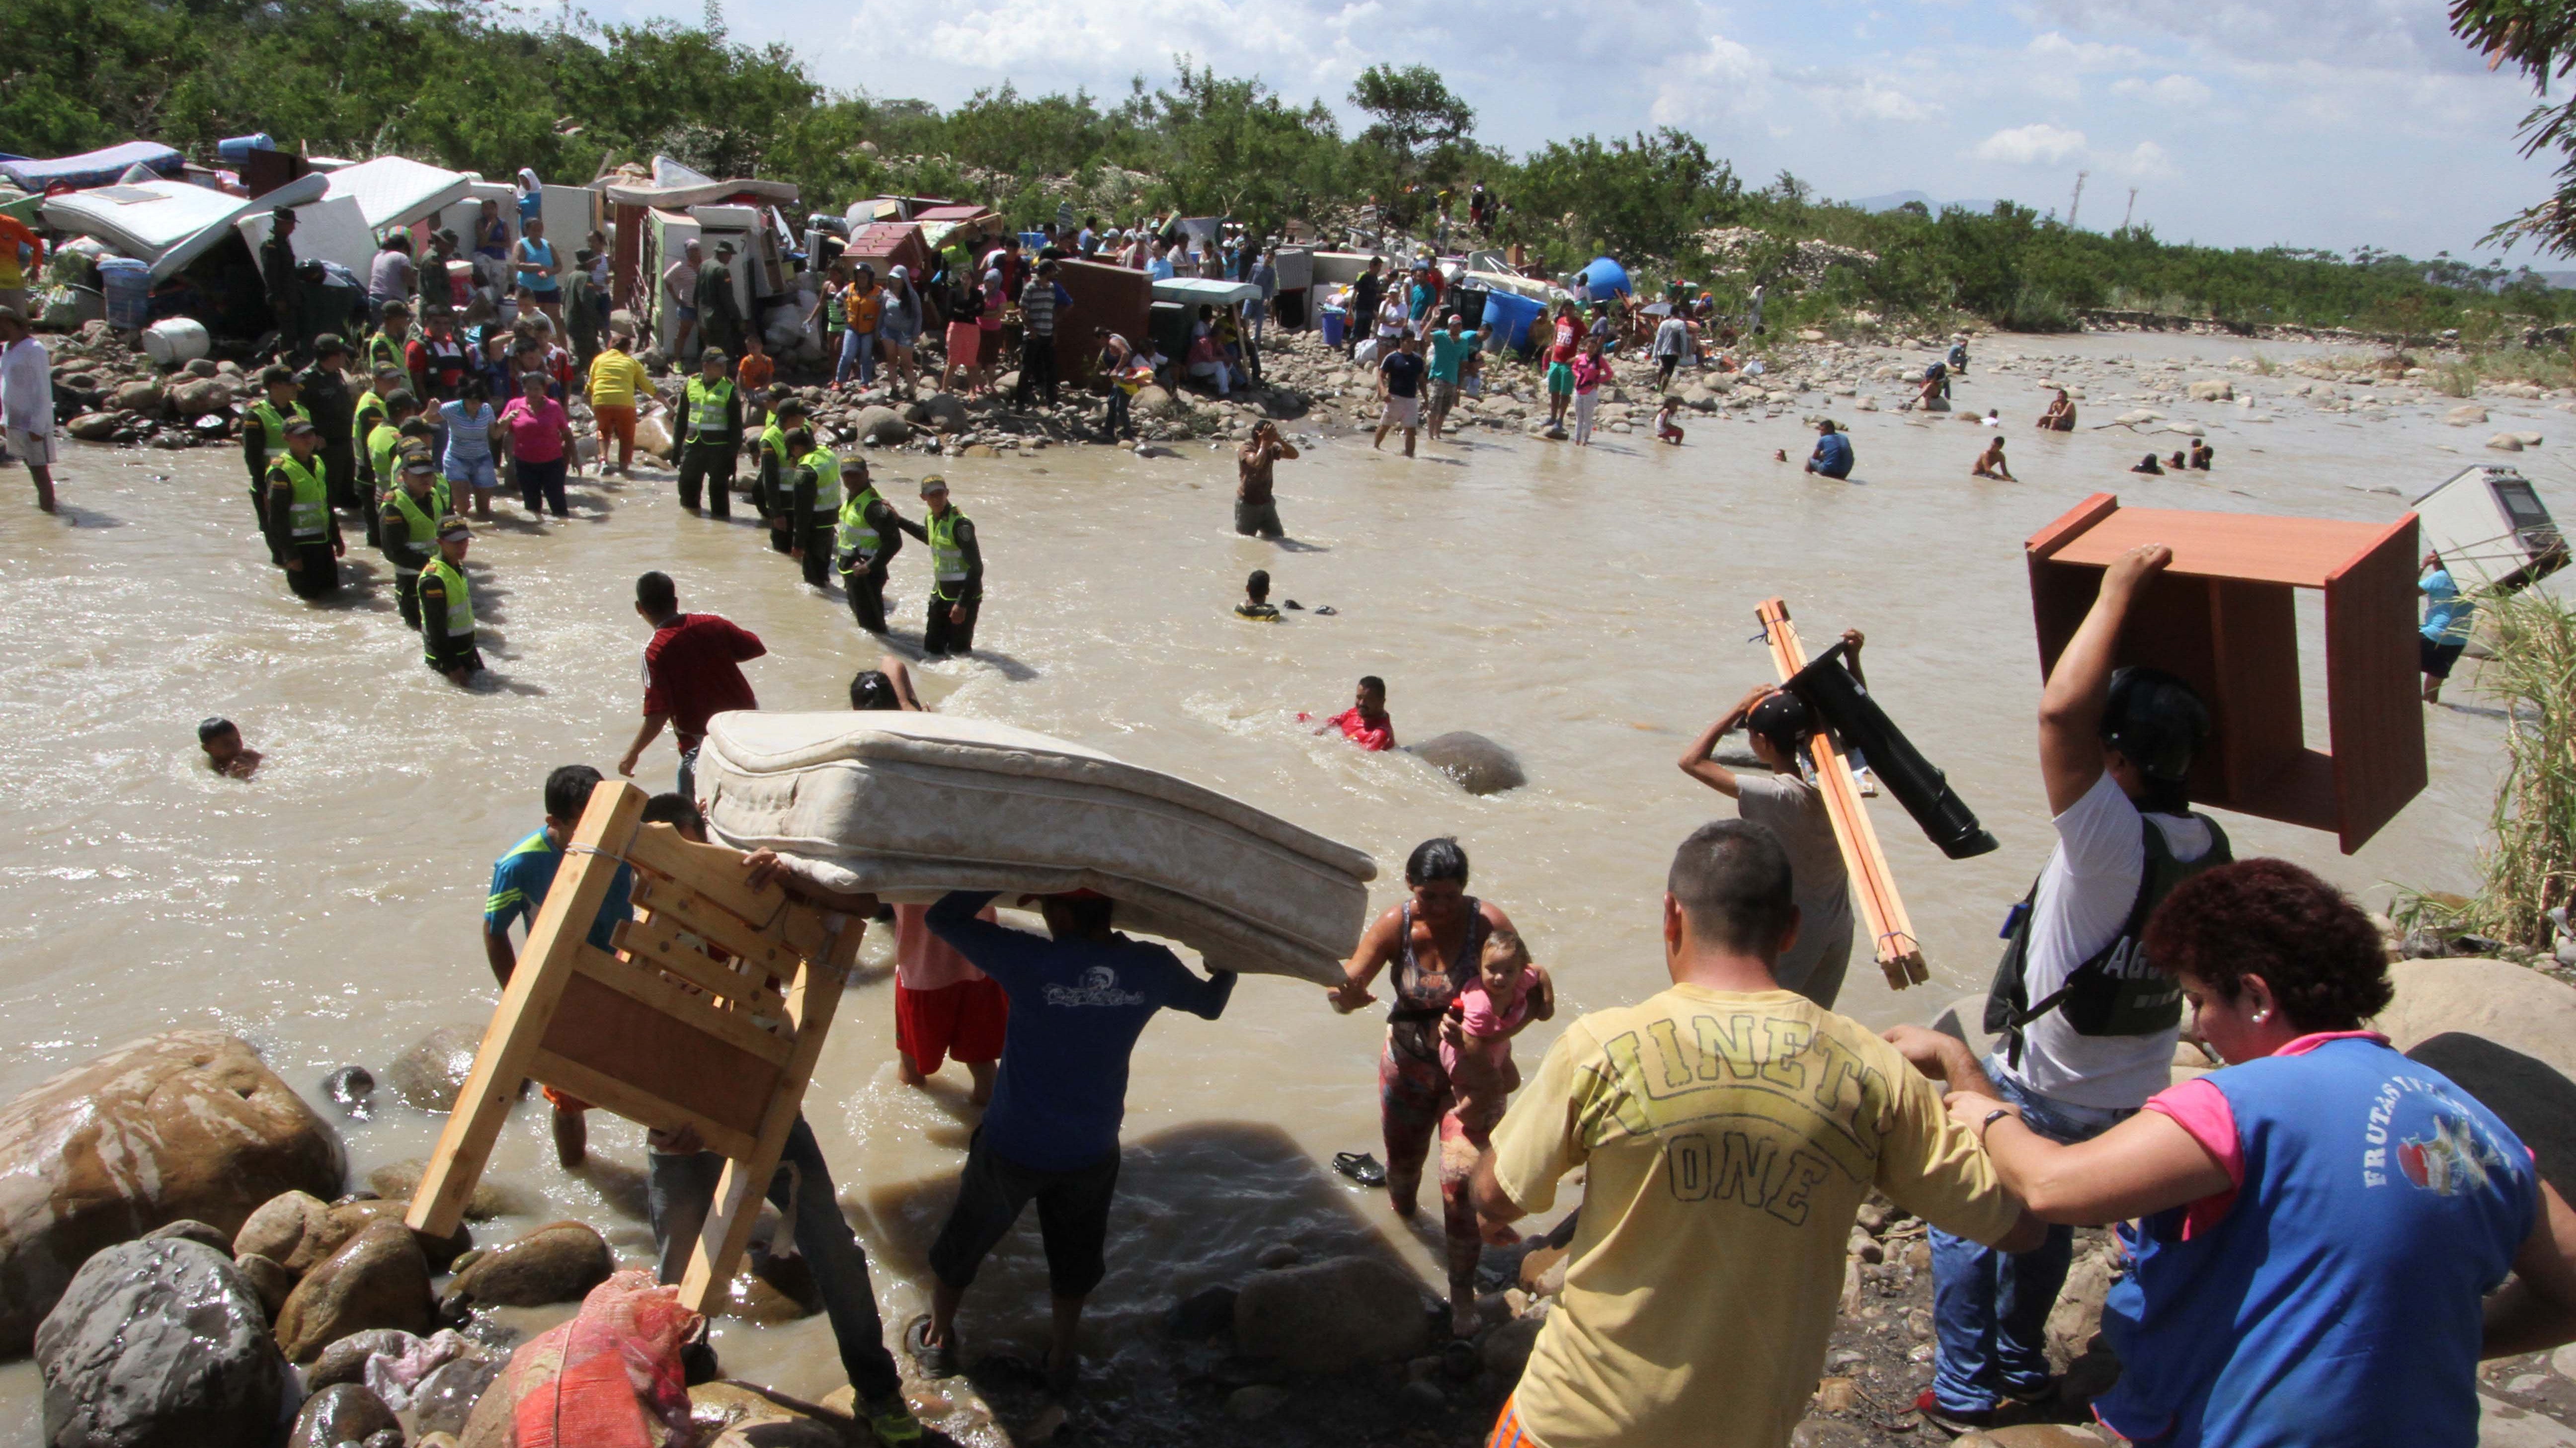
[404,781,866,1311]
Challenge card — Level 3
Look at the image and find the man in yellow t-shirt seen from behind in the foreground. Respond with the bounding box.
[1473,819,2040,1448]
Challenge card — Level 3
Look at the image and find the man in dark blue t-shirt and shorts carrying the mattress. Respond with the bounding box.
[904,891,1234,1391]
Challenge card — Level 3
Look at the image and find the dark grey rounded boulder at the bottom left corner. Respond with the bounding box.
[36,1237,296,1448]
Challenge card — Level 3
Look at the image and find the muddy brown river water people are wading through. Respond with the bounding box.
[0,327,2566,1443]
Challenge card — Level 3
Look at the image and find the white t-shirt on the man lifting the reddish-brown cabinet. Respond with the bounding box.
[2004,773,2210,1111]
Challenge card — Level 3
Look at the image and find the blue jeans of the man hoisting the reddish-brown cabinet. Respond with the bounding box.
[1932,1056,2138,1412]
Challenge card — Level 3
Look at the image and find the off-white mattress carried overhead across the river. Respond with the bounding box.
[696,711,1378,984]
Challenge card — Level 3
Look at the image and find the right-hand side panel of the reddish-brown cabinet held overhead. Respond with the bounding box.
[2326,513,2429,855]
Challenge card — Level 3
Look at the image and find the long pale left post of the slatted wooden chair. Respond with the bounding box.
[404,781,644,1237]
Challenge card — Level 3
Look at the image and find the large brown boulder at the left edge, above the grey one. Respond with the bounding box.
[0,1031,348,1358]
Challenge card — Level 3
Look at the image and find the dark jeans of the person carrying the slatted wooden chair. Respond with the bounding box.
[646,1116,904,1404]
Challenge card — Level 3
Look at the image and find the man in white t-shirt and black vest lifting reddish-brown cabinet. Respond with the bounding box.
[1914,544,2231,1425]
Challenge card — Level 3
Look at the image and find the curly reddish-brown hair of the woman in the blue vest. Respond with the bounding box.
[2143,858,2391,1031]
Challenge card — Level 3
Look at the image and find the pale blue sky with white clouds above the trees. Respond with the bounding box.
[598,0,2571,268]
